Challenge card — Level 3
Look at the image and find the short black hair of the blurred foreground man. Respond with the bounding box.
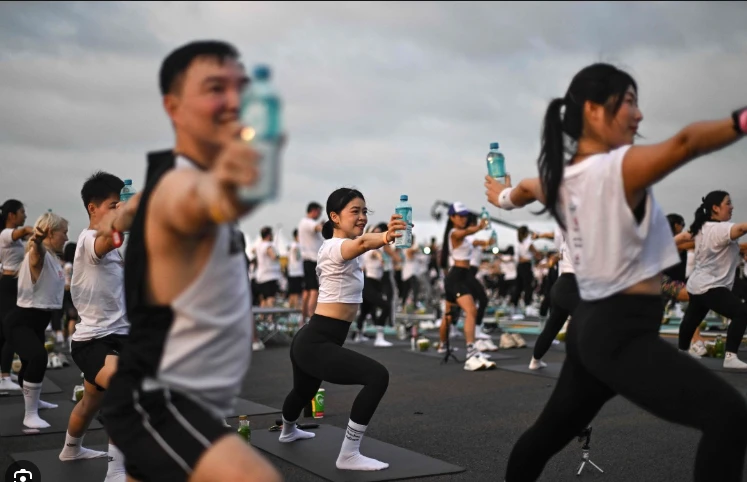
[158,40,239,95]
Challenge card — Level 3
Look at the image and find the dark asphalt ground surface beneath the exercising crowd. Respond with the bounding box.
[0,336,747,482]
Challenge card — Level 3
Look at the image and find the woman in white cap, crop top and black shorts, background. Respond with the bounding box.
[438,202,496,371]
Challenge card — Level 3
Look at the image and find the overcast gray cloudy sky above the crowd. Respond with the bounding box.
[0,2,747,247]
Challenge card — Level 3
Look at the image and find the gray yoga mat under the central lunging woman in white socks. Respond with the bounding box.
[251,425,465,482]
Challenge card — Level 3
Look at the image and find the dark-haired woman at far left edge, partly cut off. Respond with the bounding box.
[0,199,34,391]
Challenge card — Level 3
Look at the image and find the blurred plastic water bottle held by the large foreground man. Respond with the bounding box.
[239,65,283,203]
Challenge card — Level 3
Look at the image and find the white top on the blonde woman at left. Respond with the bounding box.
[16,250,65,310]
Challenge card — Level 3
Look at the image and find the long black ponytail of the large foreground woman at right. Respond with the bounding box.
[536,97,576,230]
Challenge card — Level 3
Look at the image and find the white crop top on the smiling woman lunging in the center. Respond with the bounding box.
[316,238,363,303]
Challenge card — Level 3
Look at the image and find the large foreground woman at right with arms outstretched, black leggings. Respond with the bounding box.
[485,63,747,482]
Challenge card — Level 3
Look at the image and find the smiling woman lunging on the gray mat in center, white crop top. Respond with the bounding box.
[280,188,407,470]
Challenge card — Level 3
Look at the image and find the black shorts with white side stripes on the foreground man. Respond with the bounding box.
[101,373,233,482]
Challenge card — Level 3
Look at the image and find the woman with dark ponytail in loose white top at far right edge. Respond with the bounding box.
[679,191,747,370]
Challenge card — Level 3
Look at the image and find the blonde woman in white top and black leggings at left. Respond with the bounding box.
[3,212,68,428]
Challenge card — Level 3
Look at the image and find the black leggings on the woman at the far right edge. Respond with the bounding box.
[678,287,747,353]
